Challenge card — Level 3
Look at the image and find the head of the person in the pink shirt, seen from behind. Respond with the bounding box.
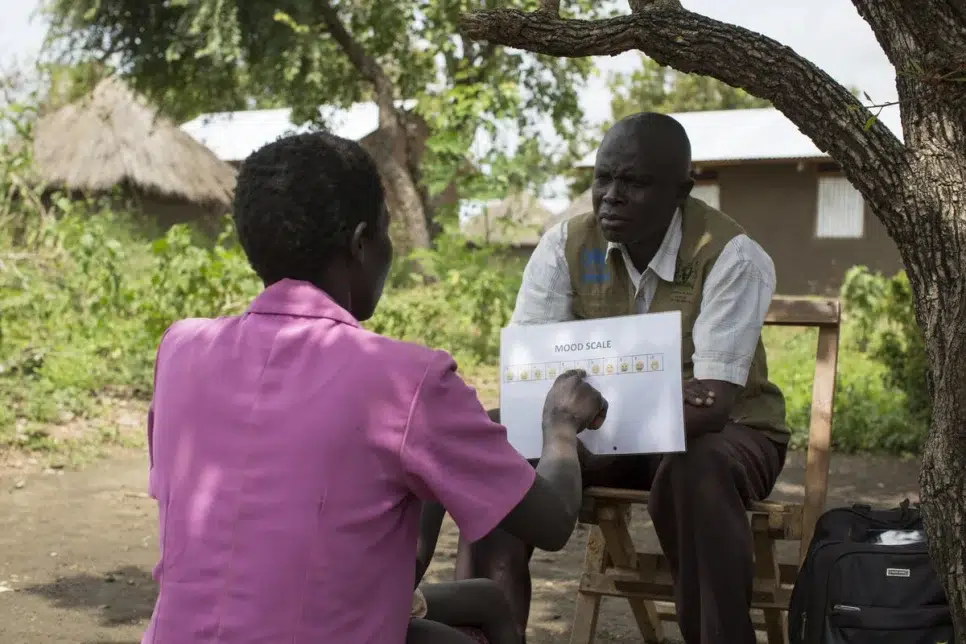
[233,132,392,320]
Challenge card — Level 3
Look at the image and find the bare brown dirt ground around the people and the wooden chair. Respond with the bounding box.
[0,453,918,644]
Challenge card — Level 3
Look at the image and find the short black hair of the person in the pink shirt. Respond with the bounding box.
[232,132,385,285]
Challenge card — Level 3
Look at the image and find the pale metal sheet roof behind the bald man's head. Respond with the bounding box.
[577,108,902,168]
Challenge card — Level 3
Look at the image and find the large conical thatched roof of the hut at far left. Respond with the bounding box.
[34,77,235,211]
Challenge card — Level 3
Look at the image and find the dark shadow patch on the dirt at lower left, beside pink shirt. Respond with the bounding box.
[22,566,157,628]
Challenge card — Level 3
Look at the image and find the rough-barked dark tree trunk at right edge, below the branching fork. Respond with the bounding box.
[893,140,966,641]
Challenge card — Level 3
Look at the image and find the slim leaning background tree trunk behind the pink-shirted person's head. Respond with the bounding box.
[316,0,430,251]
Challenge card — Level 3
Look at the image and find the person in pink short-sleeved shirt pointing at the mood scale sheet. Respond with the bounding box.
[142,133,606,644]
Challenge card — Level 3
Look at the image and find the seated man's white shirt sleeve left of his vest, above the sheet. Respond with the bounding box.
[510,223,573,324]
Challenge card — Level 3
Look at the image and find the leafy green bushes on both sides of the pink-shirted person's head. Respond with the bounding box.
[0,202,519,447]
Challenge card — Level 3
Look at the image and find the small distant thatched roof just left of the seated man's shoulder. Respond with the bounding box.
[462,193,553,247]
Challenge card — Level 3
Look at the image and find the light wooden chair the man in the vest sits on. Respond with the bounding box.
[570,298,840,644]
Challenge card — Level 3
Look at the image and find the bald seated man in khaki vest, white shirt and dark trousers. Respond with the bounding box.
[457,113,788,644]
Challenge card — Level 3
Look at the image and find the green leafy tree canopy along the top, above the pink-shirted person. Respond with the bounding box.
[39,0,620,246]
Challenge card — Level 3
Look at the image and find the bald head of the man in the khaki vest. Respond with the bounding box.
[591,112,694,244]
